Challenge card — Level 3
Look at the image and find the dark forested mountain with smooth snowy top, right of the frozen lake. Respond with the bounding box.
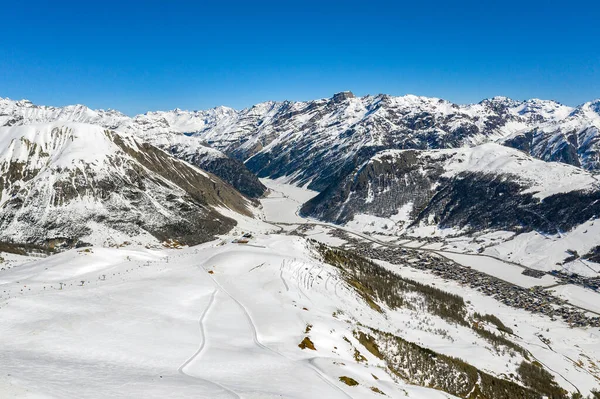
[302,143,600,234]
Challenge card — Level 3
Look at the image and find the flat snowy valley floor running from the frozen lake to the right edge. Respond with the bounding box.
[262,179,600,315]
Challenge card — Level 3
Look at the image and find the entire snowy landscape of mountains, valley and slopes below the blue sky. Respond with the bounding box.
[0,93,600,399]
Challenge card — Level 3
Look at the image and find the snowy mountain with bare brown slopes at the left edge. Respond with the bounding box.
[0,122,252,244]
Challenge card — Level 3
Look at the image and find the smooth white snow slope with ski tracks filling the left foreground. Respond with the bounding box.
[0,235,464,399]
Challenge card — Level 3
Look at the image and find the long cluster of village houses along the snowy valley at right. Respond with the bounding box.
[346,237,600,327]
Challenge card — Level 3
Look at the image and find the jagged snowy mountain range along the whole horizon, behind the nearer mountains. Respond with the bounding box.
[0,92,600,195]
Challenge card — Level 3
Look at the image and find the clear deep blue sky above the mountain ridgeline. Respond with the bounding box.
[0,0,600,114]
